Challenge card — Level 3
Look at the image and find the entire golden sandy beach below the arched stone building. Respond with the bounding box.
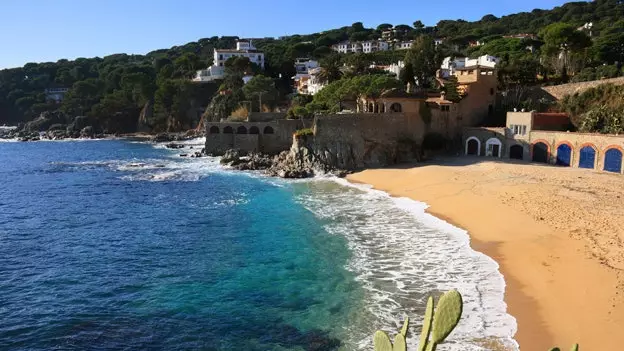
[348,158,624,351]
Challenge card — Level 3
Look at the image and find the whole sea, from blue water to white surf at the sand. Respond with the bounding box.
[0,139,518,351]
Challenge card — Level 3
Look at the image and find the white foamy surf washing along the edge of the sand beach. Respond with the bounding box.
[298,179,518,350]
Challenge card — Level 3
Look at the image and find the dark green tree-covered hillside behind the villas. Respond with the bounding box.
[0,0,624,132]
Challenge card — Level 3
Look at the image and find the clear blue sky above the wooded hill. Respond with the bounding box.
[0,0,565,69]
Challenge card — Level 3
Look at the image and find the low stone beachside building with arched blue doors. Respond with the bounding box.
[463,112,624,173]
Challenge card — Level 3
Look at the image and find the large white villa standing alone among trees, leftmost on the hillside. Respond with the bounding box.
[193,40,264,83]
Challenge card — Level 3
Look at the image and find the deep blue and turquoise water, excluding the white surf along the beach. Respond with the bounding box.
[0,141,362,350]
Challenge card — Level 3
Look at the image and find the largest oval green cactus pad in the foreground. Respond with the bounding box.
[431,290,463,350]
